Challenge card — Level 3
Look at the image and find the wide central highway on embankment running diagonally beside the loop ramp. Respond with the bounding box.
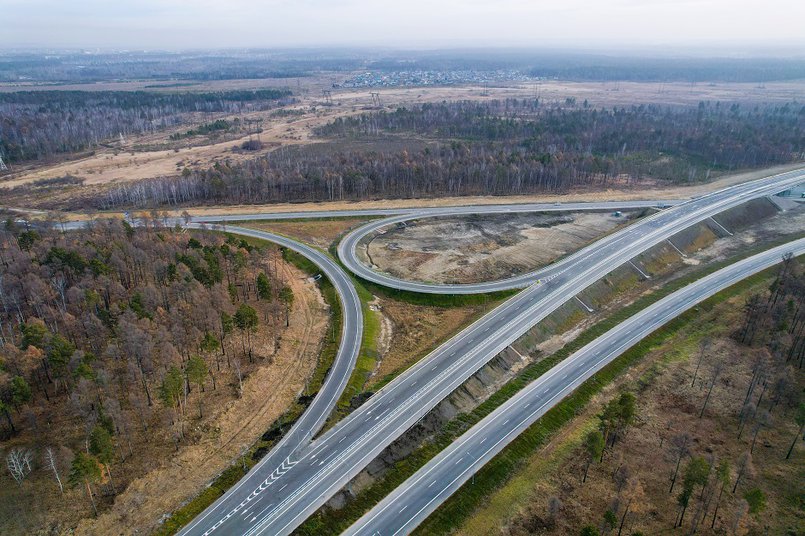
[183,170,805,535]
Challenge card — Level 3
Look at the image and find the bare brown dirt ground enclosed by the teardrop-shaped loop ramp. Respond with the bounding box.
[362,213,629,283]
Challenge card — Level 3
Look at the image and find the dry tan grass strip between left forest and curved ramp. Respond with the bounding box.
[76,266,327,535]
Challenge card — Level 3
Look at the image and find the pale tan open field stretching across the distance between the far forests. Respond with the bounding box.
[0,75,805,191]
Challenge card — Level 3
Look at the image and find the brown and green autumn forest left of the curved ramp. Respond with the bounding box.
[0,215,294,514]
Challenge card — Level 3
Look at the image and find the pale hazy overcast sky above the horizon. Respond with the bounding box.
[0,0,805,51]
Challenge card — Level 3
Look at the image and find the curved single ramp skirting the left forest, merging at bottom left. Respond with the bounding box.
[177,223,363,533]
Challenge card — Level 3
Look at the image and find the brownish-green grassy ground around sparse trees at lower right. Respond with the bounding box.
[457,286,803,536]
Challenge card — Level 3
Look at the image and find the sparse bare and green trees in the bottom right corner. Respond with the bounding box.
[560,255,805,536]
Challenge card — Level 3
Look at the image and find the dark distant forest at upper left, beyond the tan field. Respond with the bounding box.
[0,89,291,163]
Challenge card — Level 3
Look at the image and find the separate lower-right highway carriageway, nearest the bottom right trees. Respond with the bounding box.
[345,239,805,536]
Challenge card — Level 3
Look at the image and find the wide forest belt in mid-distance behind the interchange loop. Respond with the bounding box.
[96,99,805,209]
